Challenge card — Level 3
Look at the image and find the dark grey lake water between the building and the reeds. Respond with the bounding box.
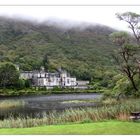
[0,93,102,119]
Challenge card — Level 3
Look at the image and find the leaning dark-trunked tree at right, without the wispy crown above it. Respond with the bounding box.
[110,32,139,91]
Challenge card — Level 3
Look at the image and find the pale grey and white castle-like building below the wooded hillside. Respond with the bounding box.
[20,71,77,88]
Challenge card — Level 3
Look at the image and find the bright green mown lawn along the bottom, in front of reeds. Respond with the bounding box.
[0,121,140,135]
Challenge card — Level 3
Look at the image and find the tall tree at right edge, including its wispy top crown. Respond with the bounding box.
[110,12,140,91]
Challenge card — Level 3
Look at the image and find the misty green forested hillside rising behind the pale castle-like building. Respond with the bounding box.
[0,17,115,80]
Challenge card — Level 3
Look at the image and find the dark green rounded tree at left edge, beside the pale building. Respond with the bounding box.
[0,62,19,88]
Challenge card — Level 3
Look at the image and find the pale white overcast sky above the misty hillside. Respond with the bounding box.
[0,6,140,30]
